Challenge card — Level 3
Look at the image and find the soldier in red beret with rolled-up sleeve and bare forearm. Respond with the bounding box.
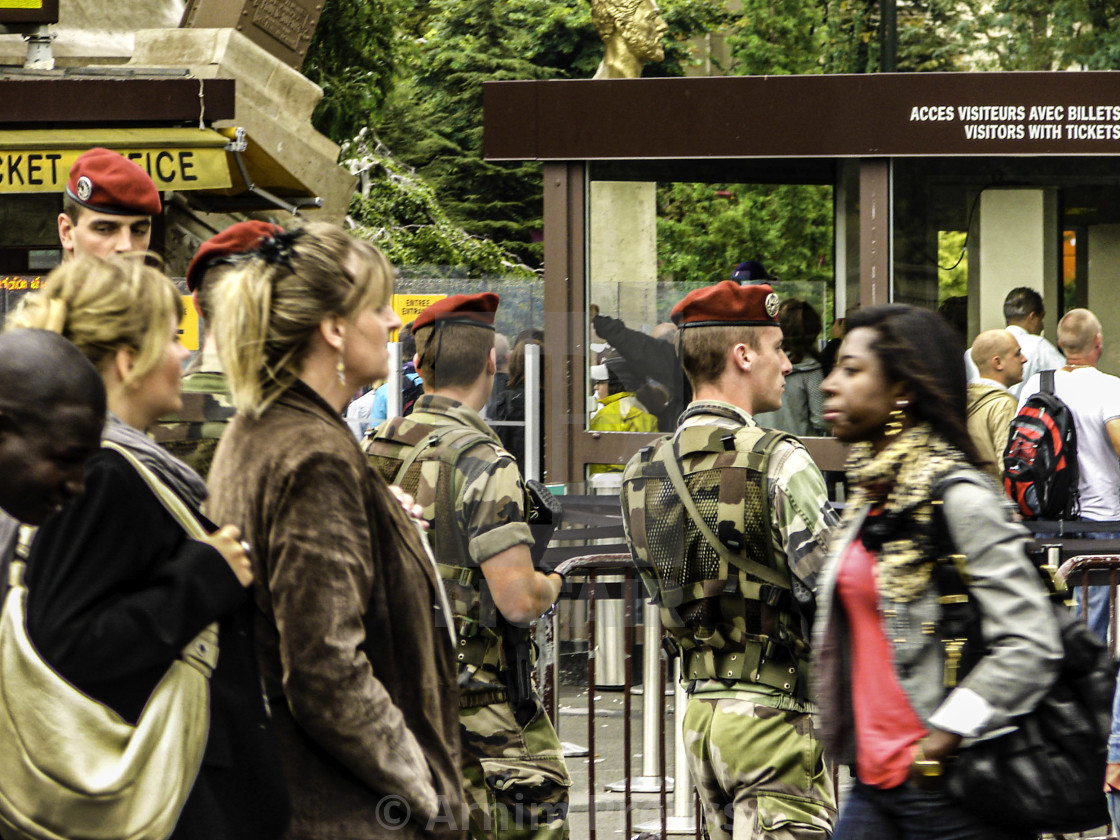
[364,292,571,840]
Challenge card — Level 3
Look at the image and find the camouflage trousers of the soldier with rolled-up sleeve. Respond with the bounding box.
[459,689,571,840]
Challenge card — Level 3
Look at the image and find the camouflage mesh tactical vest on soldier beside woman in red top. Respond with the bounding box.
[623,426,809,697]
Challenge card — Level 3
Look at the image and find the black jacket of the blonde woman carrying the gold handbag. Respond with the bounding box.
[27,449,288,840]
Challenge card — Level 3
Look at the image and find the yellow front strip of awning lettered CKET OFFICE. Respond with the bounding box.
[0,128,232,194]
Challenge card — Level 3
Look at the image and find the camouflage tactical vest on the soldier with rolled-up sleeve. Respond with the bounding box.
[363,417,515,672]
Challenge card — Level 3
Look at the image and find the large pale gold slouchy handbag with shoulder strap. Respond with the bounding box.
[0,442,218,840]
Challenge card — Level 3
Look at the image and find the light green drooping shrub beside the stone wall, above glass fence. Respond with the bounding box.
[343,133,536,278]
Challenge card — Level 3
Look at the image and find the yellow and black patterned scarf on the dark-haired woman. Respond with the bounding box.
[844,423,968,601]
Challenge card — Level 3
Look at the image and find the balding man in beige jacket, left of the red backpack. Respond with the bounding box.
[969,329,1026,483]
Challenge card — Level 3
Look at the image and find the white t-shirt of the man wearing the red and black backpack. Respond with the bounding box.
[1019,367,1120,521]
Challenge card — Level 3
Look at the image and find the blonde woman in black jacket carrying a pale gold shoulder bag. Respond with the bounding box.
[7,256,287,840]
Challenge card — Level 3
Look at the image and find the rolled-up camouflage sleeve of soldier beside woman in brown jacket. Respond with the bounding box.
[458,447,533,563]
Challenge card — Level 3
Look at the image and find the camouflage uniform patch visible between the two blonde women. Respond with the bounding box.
[149,353,234,478]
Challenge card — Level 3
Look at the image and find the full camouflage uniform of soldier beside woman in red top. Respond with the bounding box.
[622,401,837,840]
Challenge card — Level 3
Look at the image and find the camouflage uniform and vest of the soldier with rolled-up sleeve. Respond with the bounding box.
[364,394,571,840]
